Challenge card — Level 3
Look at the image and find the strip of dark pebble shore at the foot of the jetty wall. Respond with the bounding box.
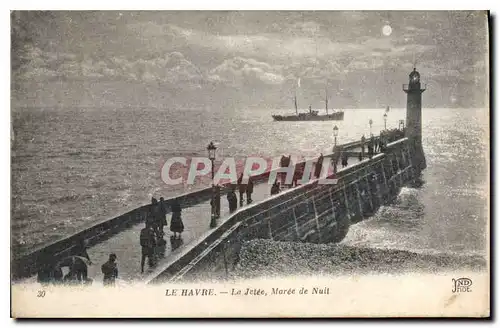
[231,239,487,279]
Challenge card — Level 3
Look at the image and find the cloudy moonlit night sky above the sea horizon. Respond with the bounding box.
[12,11,488,109]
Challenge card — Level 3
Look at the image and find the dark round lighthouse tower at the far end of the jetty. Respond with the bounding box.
[403,68,427,171]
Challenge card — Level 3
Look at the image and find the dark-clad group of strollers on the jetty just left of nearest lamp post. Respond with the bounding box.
[139,197,184,273]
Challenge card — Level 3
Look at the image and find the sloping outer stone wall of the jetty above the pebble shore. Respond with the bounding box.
[148,138,420,283]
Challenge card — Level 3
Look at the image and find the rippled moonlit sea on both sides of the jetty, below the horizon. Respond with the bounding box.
[11,108,490,272]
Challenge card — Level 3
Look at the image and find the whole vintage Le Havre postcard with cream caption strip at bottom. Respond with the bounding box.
[10,10,490,318]
